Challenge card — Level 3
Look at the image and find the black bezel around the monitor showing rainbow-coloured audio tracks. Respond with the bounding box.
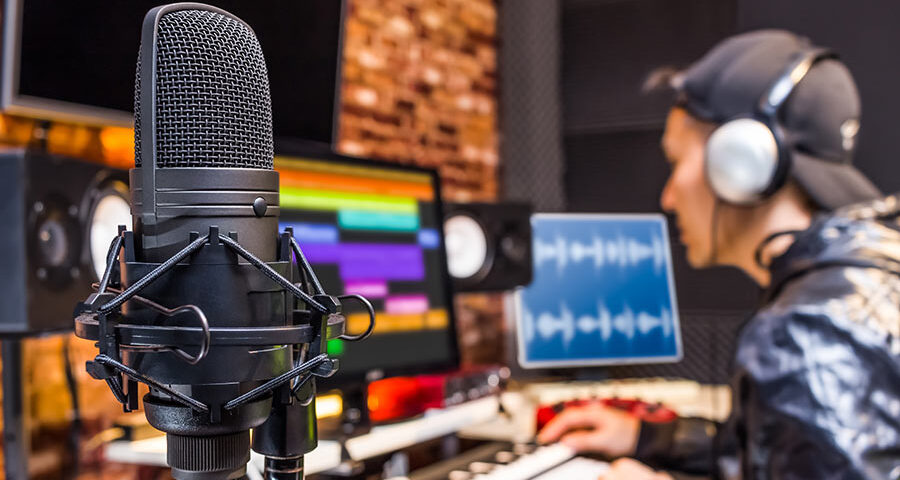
[275,143,460,391]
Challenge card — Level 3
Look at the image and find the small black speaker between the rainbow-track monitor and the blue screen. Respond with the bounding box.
[444,203,532,292]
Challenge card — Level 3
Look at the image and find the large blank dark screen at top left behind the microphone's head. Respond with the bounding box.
[3,0,344,143]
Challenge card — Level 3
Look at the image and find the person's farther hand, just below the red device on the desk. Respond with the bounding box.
[537,405,641,457]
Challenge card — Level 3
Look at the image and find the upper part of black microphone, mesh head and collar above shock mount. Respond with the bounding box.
[131,0,278,262]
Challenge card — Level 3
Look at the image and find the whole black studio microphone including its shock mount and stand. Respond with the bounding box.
[76,3,374,480]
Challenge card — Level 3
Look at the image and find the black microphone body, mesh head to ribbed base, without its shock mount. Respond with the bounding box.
[130,4,293,479]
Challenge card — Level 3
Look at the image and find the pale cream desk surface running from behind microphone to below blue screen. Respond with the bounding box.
[106,379,730,478]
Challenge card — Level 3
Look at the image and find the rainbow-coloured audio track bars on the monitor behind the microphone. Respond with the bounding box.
[275,157,449,364]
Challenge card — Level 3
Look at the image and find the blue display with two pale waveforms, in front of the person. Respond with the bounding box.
[516,214,681,368]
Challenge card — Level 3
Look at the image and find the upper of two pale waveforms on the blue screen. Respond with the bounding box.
[534,234,666,273]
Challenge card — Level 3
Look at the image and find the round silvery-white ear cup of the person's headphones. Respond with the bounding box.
[705,118,780,205]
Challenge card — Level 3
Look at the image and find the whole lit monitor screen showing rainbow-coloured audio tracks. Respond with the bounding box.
[275,156,456,378]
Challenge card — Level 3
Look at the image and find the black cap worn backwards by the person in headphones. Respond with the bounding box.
[673,30,882,210]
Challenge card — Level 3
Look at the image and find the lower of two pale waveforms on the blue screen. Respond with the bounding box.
[523,301,673,349]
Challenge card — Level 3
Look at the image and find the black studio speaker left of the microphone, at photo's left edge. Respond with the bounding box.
[0,149,131,335]
